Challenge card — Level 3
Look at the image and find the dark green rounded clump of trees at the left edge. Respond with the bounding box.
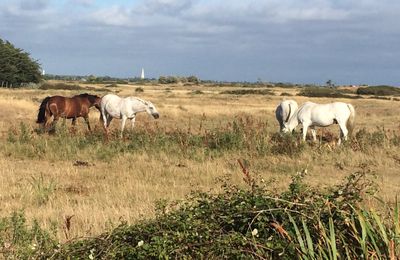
[0,39,42,87]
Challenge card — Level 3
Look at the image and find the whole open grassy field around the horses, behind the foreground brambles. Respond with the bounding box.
[0,81,400,240]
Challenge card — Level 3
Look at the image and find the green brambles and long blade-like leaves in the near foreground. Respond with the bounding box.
[0,167,400,259]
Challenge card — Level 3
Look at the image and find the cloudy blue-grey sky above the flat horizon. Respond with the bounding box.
[0,0,400,86]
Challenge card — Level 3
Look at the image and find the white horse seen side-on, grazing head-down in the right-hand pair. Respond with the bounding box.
[283,102,356,145]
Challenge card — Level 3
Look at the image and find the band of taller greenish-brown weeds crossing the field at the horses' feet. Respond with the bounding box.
[0,117,400,161]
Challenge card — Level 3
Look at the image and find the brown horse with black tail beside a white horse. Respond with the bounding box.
[36,93,101,131]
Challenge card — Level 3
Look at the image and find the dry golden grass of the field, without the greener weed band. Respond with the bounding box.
[0,85,400,239]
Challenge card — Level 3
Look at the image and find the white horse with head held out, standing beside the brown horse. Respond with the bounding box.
[100,94,160,138]
